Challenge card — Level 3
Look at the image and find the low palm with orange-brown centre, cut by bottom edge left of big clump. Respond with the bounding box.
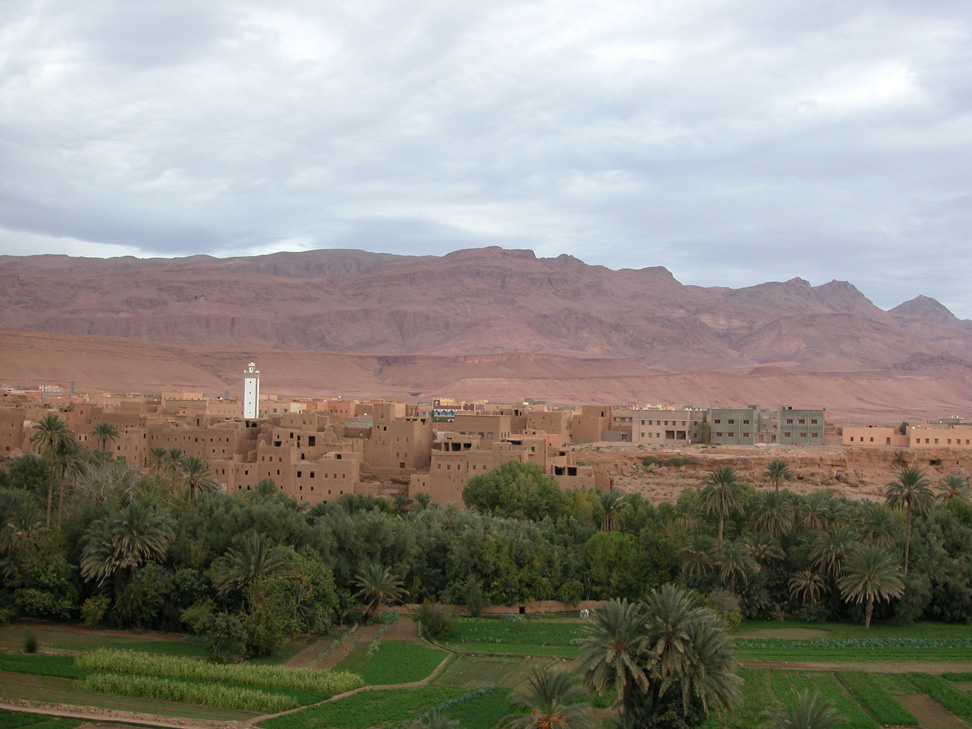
[499,667,599,729]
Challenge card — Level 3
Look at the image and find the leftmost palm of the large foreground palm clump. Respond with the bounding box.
[579,600,648,712]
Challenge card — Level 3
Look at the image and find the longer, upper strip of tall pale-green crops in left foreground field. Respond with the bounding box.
[76,648,363,695]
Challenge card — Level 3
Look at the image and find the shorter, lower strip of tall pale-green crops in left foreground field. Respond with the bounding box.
[76,673,298,714]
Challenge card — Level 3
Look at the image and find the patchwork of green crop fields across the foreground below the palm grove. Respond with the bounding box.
[0,617,972,729]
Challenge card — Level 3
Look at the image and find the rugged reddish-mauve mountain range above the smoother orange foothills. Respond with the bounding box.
[0,248,972,374]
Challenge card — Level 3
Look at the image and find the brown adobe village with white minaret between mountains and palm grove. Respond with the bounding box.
[0,362,972,506]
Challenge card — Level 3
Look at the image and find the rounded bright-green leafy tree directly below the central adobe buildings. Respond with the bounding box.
[462,461,567,521]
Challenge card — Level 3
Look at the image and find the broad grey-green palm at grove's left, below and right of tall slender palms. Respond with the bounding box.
[81,501,175,600]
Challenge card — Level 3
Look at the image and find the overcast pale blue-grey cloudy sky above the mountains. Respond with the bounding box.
[0,0,972,318]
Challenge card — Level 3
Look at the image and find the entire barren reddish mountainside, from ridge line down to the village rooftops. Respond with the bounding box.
[0,248,972,418]
